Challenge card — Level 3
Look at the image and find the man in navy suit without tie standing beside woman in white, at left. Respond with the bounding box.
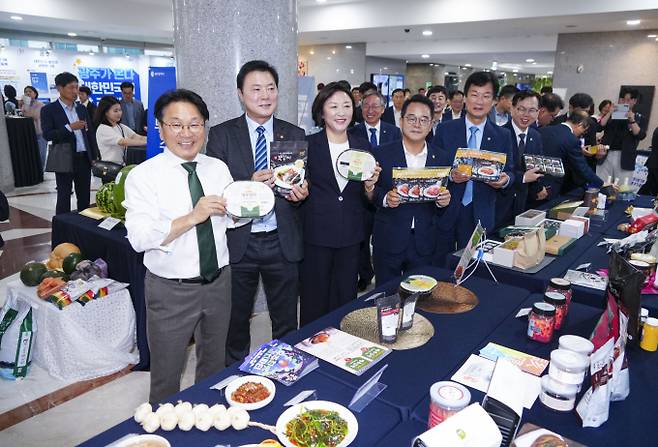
[41,72,98,214]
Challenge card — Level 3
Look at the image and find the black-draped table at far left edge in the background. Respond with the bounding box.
[5,117,43,187]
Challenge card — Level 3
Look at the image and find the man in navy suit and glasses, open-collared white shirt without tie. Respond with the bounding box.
[373,95,450,286]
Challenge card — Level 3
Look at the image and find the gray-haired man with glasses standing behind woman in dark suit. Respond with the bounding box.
[349,90,402,292]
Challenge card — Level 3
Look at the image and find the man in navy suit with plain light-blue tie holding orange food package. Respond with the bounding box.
[432,71,514,265]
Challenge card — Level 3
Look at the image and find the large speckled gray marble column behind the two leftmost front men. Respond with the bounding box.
[173,0,297,125]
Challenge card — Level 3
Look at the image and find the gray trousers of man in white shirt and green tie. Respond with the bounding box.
[144,266,231,403]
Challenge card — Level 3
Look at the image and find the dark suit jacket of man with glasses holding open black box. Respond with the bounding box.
[500,120,544,214]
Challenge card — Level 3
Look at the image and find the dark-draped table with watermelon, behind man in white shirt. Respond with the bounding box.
[52,213,150,370]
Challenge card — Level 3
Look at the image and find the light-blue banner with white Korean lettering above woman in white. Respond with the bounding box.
[78,67,142,104]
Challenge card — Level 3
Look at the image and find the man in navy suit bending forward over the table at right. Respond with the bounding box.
[539,111,603,199]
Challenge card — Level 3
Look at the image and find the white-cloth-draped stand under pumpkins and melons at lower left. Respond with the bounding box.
[7,281,139,381]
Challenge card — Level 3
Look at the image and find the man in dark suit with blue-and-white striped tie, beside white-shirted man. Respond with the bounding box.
[206,60,308,366]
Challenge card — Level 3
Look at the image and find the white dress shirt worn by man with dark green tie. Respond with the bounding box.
[123,148,233,279]
